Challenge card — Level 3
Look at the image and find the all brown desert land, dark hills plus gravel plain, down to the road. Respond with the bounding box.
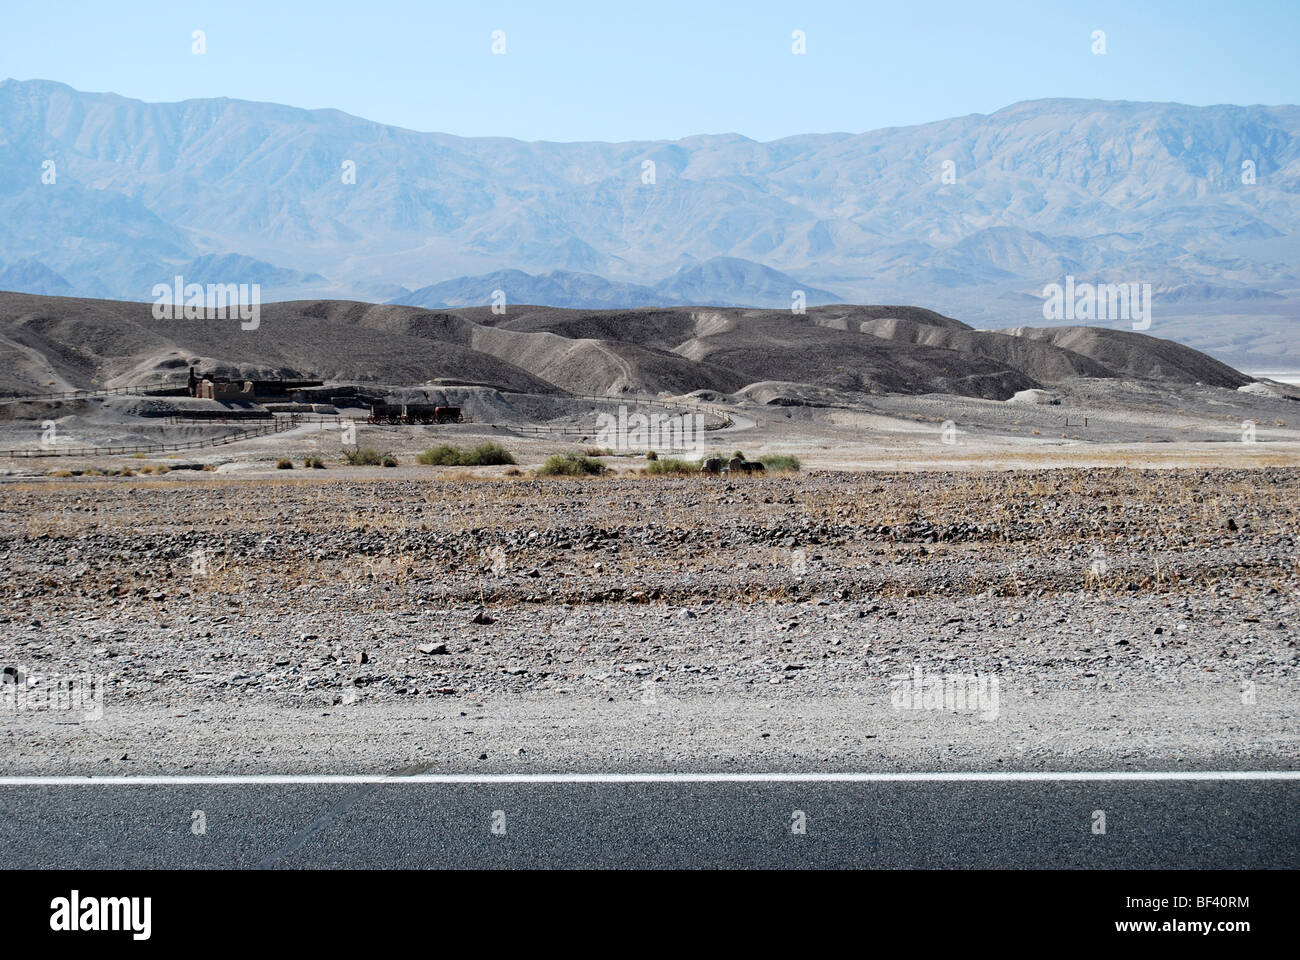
[0,294,1300,774]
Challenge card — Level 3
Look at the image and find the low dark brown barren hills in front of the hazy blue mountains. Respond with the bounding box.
[0,293,1249,399]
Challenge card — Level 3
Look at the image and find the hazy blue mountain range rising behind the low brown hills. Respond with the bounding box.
[0,81,1300,368]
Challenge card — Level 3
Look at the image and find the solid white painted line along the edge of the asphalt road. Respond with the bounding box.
[0,770,1300,788]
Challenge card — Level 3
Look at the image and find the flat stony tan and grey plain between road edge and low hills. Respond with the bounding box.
[0,407,1300,774]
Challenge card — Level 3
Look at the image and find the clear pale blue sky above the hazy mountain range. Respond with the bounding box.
[0,0,1300,140]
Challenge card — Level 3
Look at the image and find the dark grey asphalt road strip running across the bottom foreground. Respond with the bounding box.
[0,774,1300,869]
